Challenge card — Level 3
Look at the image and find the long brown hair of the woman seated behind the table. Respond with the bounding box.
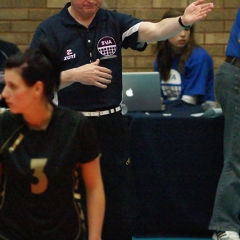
[153,8,198,81]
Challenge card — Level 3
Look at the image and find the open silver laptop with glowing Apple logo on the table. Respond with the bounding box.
[121,72,164,112]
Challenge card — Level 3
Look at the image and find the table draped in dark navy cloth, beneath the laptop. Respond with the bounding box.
[128,101,224,237]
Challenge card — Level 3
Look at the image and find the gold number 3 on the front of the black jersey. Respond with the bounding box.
[30,158,48,194]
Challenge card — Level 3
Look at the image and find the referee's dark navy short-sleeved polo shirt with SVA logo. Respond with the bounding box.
[31,3,147,111]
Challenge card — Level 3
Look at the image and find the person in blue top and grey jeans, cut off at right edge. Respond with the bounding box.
[209,8,240,240]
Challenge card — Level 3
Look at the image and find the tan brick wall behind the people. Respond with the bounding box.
[0,0,240,71]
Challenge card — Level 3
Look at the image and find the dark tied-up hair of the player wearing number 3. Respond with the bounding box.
[5,42,61,98]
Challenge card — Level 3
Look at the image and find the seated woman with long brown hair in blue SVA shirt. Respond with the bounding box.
[153,9,214,104]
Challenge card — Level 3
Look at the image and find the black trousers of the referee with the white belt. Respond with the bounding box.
[90,112,134,240]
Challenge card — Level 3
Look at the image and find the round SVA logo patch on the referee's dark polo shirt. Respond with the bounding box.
[97,37,117,56]
